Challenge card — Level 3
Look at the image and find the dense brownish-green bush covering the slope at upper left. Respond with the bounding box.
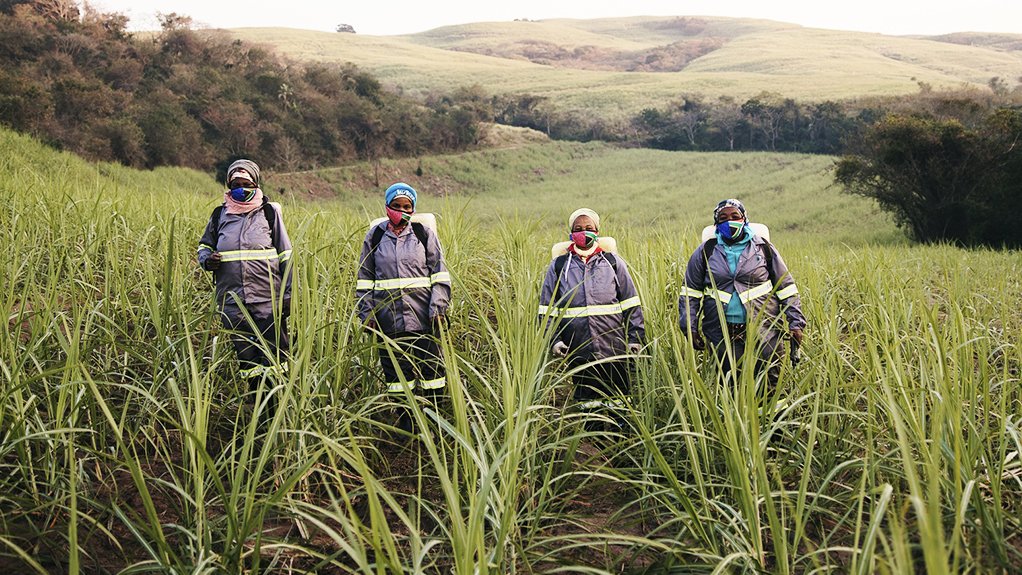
[0,0,482,171]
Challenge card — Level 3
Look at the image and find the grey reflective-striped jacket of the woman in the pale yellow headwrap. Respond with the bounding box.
[540,252,646,361]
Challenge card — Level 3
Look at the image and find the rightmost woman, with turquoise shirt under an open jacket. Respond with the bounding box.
[679,199,805,387]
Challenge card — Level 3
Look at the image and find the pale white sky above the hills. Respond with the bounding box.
[88,0,1022,36]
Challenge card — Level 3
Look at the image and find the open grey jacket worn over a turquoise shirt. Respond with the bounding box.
[678,236,805,352]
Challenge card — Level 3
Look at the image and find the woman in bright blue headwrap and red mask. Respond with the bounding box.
[355,183,451,431]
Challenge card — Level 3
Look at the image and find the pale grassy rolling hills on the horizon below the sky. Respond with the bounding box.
[228,16,1022,117]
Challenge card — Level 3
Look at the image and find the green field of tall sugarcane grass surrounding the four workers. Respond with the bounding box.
[0,128,1022,575]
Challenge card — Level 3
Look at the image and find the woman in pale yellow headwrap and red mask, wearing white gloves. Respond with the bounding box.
[539,207,646,421]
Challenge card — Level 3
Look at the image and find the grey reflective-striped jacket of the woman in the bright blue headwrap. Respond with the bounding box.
[355,222,451,334]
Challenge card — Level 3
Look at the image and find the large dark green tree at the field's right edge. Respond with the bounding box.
[835,110,1022,246]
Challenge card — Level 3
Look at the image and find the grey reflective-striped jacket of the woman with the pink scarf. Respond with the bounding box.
[198,205,291,318]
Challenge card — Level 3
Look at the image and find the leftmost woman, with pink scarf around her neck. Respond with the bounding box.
[198,159,291,422]
